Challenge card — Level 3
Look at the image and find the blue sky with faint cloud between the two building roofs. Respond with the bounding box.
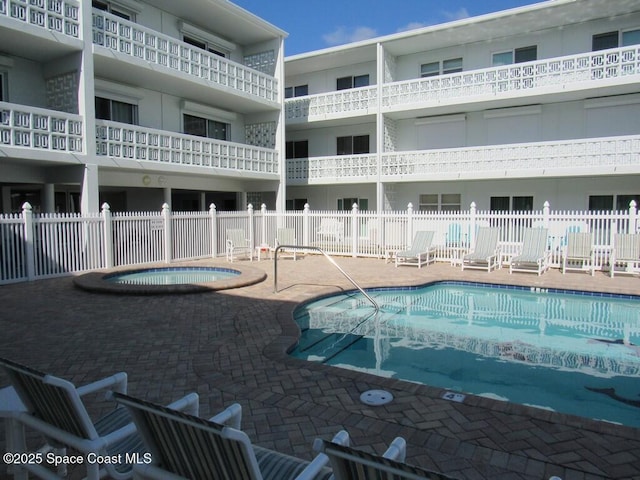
[231,0,539,56]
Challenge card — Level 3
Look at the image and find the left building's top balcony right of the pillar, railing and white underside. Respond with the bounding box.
[93,10,279,112]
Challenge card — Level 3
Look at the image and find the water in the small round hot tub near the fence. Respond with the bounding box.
[104,267,240,285]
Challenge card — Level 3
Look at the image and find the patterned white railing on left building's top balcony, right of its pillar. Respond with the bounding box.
[93,10,278,102]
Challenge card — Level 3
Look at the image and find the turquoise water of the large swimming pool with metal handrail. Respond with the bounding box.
[291,282,640,427]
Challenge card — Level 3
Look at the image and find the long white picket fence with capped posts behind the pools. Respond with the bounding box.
[0,202,640,284]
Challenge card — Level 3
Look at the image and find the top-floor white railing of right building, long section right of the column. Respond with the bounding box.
[382,45,640,108]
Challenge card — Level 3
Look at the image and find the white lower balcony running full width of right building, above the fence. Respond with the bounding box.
[287,135,640,185]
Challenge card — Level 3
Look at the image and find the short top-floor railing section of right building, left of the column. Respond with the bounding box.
[285,86,378,120]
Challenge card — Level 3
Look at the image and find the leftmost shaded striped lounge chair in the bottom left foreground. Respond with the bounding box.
[0,358,197,480]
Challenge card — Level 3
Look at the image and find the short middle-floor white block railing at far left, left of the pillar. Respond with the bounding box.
[0,102,84,153]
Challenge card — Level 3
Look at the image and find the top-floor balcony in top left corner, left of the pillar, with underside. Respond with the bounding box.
[0,0,82,60]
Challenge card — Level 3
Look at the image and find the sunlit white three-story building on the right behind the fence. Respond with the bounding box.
[285,0,640,211]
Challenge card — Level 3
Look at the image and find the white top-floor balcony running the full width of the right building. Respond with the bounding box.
[285,45,640,124]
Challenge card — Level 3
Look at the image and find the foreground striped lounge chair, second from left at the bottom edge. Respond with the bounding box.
[114,394,348,480]
